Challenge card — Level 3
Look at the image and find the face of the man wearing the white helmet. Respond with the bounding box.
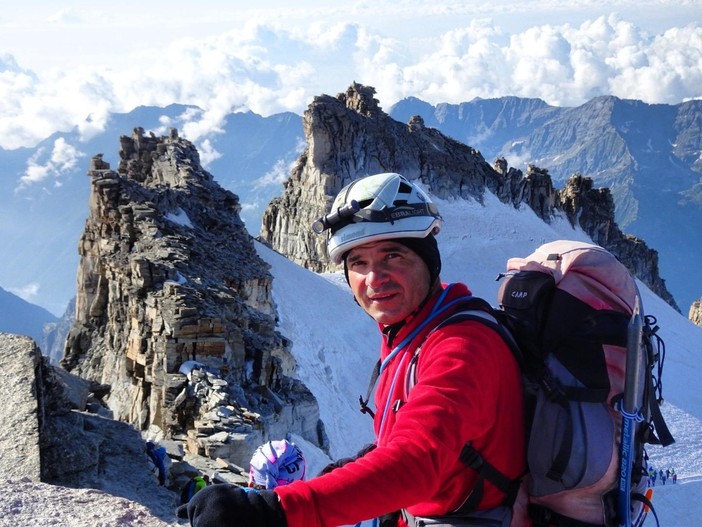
[346,240,429,325]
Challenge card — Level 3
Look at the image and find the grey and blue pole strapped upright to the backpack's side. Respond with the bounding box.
[618,295,643,527]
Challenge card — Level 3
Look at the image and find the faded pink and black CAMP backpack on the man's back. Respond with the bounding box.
[394,240,674,527]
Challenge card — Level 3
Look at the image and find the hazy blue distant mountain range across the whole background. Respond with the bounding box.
[0,93,702,316]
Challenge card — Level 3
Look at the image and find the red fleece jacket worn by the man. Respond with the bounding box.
[275,284,525,527]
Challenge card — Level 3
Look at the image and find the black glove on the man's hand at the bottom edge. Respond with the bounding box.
[176,484,288,527]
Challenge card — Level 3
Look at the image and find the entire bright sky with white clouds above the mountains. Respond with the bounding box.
[0,0,702,149]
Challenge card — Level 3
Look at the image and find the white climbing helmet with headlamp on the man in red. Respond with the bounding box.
[312,173,441,264]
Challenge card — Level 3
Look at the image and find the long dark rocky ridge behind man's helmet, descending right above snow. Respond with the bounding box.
[260,83,678,309]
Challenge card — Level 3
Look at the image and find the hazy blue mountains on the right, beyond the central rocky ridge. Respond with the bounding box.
[389,97,702,315]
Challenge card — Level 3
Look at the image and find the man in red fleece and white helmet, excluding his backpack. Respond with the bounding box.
[179,174,525,527]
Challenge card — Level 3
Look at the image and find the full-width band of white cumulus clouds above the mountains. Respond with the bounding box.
[0,10,702,151]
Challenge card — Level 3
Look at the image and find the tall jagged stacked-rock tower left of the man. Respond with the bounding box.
[61,129,326,466]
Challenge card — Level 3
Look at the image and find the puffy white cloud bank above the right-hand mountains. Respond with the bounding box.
[382,15,702,106]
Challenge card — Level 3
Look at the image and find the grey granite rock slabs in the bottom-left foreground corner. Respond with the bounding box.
[0,333,188,527]
